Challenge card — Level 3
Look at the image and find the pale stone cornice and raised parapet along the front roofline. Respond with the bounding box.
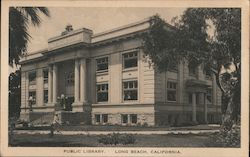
[20,18,174,64]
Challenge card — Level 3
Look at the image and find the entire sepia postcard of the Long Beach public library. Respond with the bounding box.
[1,2,249,156]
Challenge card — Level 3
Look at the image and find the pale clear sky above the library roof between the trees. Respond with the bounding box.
[27,7,185,54]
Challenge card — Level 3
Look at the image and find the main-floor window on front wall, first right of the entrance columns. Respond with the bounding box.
[97,84,109,102]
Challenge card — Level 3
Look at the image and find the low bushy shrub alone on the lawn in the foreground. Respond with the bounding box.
[98,133,135,145]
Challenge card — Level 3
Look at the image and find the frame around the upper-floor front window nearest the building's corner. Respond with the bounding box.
[122,50,139,70]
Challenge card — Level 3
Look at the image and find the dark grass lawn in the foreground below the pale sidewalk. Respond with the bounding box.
[10,134,224,147]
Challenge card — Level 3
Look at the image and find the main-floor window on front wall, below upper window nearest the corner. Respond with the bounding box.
[123,81,138,100]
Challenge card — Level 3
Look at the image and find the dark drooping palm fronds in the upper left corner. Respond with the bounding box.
[9,7,50,66]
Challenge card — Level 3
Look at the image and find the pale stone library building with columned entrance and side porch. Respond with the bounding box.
[20,19,221,126]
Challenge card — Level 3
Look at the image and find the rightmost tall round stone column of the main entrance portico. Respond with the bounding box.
[80,58,86,102]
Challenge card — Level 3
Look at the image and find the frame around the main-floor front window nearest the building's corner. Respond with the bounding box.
[122,79,139,102]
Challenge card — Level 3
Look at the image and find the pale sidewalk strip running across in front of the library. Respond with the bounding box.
[14,129,219,135]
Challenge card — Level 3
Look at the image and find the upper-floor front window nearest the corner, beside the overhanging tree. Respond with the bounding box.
[122,51,138,69]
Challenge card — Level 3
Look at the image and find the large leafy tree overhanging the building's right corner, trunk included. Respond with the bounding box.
[143,8,241,130]
